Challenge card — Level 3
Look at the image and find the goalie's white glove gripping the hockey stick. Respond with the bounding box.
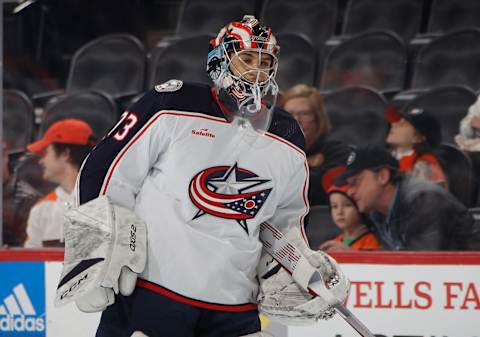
[257,224,350,325]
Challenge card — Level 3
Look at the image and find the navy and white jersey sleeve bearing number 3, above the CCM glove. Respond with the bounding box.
[76,91,173,209]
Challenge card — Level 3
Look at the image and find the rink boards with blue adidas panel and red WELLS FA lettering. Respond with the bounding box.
[0,250,480,337]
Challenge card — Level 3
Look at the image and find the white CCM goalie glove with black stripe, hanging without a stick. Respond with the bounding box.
[55,196,147,312]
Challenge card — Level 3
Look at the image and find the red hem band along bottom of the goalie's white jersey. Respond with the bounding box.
[137,279,257,312]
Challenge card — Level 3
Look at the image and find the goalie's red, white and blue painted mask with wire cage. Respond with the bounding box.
[207,15,280,130]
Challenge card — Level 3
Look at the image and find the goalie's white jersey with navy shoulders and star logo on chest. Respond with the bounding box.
[77,81,308,311]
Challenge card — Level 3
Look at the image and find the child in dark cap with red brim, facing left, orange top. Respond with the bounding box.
[385,106,447,187]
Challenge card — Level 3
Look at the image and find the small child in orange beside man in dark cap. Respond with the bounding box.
[319,166,380,253]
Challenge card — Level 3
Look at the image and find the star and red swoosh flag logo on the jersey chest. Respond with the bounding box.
[189,164,272,234]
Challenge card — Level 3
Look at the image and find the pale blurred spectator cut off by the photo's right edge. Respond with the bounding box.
[455,96,480,152]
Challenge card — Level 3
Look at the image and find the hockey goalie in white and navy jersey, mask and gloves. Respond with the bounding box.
[56,15,349,337]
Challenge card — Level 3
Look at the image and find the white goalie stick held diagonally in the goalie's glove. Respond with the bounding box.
[260,223,375,337]
